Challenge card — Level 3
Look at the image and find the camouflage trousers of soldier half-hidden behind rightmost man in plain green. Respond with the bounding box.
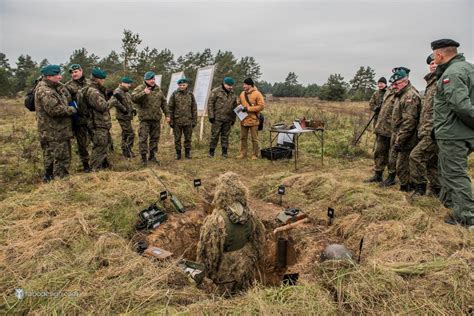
[410,136,439,189]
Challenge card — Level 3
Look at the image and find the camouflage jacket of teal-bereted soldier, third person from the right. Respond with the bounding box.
[392,83,421,151]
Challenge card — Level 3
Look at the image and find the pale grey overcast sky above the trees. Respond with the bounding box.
[0,0,474,90]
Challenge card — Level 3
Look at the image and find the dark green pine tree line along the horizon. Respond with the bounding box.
[0,30,376,101]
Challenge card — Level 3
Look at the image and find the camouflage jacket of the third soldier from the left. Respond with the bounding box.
[83,82,112,129]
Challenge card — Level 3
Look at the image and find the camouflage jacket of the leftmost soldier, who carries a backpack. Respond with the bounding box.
[35,79,74,142]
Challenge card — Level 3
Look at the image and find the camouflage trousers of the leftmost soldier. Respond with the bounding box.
[40,140,71,178]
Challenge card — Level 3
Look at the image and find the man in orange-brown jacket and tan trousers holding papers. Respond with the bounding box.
[237,78,265,160]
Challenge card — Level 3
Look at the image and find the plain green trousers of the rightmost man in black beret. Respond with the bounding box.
[436,139,474,225]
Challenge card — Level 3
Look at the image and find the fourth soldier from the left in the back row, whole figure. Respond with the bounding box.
[109,77,137,158]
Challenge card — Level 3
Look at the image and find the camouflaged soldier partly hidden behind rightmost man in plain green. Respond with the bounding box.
[410,55,440,195]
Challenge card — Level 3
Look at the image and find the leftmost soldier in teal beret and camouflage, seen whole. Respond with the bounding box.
[35,65,77,182]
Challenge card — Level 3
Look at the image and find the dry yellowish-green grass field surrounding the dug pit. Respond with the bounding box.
[0,99,474,315]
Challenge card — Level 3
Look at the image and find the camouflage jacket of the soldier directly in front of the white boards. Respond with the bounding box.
[169,89,197,126]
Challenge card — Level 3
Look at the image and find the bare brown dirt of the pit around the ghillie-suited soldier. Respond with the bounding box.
[135,193,339,286]
